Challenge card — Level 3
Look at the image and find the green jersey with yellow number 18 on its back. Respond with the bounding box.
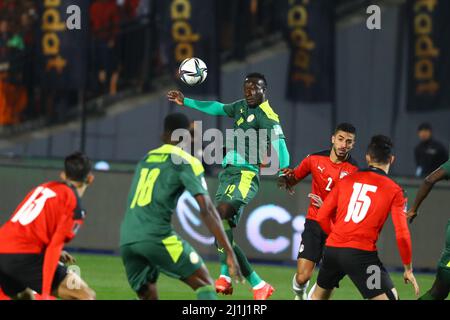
[120,144,208,245]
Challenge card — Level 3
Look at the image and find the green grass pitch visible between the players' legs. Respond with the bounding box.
[74,254,444,300]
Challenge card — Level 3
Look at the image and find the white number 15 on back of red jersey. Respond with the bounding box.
[344,183,378,223]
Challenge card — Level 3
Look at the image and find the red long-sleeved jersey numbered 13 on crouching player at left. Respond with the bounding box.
[0,182,85,296]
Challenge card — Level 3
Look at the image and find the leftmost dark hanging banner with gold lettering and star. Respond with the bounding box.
[35,0,89,89]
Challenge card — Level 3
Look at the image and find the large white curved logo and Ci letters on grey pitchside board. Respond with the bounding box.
[173,192,305,262]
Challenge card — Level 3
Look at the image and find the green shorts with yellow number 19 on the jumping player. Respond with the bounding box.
[215,166,259,228]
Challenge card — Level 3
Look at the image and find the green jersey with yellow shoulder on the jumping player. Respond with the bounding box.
[223,100,285,172]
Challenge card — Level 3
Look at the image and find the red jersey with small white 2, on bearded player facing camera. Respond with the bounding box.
[294,150,358,220]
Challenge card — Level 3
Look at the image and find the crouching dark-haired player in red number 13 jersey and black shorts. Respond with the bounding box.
[0,152,95,300]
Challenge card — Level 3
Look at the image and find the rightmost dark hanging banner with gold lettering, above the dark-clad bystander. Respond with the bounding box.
[407,0,450,111]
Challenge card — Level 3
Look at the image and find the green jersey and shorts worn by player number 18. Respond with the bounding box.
[120,145,208,291]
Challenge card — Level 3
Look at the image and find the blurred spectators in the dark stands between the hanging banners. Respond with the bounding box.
[0,0,276,128]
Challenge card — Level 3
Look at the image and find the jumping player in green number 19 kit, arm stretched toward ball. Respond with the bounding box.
[167,73,289,300]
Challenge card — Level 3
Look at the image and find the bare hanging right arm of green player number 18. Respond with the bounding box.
[195,194,242,282]
